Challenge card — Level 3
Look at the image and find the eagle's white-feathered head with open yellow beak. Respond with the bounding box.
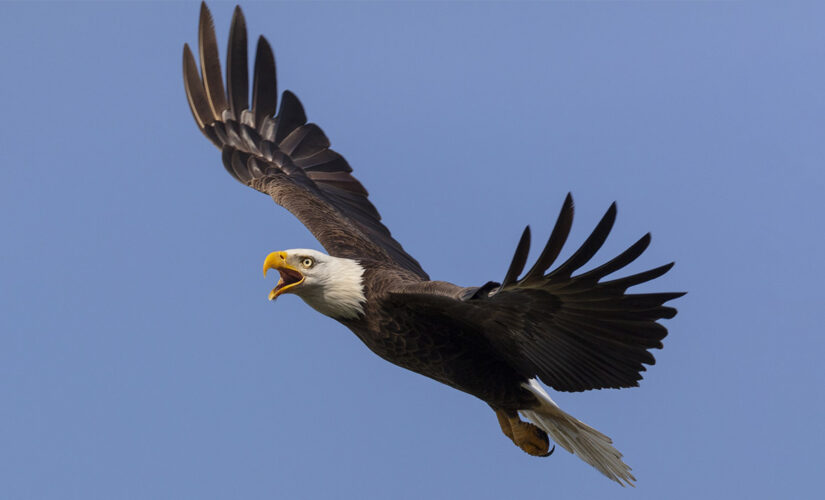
[264,248,367,319]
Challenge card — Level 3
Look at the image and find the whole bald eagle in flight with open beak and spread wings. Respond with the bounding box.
[183,4,683,485]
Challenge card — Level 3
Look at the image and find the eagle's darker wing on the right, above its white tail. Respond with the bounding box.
[392,195,684,391]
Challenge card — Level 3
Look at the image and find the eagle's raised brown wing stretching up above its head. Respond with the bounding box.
[183,3,427,279]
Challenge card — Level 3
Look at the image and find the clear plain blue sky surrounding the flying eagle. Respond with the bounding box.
[0,1,825,499]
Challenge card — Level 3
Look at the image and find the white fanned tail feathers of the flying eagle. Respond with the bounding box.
[521,379,636,486]
